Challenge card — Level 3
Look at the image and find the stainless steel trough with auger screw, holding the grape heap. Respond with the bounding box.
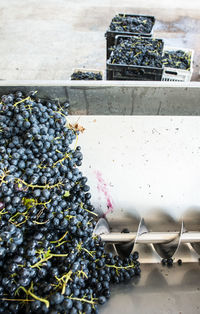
[0,81,200,314]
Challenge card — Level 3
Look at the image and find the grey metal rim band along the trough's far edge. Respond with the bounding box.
[0,81,200,115]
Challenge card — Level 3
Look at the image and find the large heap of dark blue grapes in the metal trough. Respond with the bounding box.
[0,91,140,314]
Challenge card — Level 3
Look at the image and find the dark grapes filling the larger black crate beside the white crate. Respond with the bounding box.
[109,37,163,68]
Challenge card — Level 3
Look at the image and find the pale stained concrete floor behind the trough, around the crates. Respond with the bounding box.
[0,0,200,81]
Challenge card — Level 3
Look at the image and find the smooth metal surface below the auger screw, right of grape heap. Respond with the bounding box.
[100,263,200,314]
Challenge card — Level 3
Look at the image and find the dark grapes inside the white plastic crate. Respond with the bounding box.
[162,50,191,70]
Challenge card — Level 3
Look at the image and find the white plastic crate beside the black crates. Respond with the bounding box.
[162,47,194,82]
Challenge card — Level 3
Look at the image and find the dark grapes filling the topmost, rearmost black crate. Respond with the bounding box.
[110,14,154,34]
